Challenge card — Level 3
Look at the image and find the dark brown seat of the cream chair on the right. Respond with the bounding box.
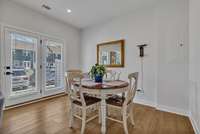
[106,95,125,107]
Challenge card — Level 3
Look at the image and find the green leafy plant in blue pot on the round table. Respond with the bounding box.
[89,64,106,83]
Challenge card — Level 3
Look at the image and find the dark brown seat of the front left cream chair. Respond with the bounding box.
[73,95,101,106]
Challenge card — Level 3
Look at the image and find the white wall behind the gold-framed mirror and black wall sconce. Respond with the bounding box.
[81,8,157,103]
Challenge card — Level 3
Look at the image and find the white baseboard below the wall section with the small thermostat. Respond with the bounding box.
[156,105,189,116]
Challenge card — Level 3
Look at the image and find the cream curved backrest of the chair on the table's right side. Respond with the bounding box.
[123,72,139,106]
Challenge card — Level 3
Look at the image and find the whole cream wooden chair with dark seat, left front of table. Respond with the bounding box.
[66,72,101,134]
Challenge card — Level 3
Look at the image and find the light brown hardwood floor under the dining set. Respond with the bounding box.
[0,96,194,134]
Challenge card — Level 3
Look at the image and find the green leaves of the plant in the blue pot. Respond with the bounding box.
[89,64,106,78]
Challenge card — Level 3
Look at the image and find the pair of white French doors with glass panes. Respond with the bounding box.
[2,27,64,106]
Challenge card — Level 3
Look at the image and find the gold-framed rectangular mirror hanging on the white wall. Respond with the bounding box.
[97,40,125,67]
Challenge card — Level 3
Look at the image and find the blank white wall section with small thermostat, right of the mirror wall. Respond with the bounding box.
[156,0,189,114]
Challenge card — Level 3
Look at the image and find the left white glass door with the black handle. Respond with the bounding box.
[4,28,40,105]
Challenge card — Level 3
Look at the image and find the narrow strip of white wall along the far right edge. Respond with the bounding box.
[189,0,200,133]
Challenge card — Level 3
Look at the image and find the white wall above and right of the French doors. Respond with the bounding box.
[0,0,80,70]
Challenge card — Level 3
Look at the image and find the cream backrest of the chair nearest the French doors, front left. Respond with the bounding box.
[65,71,83,101]
